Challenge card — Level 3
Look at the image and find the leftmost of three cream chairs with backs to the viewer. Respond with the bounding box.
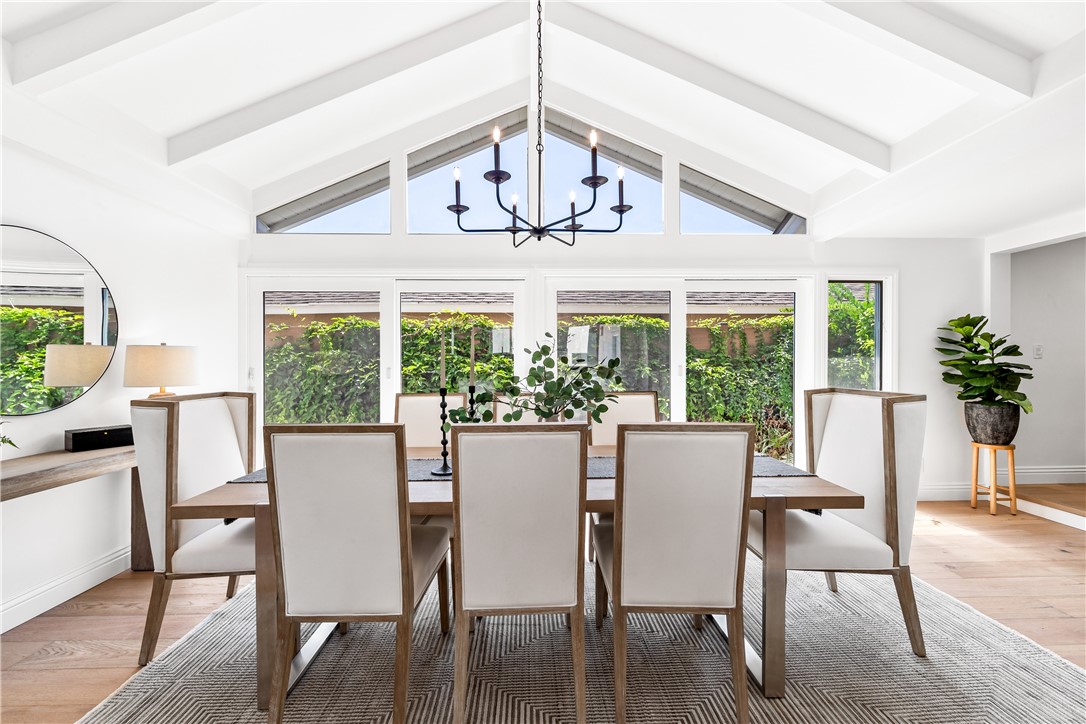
[264,424,449,724]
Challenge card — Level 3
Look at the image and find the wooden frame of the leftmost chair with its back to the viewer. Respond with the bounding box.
[264,423,449,724]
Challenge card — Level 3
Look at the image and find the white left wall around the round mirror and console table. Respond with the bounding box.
[0,140,244,631]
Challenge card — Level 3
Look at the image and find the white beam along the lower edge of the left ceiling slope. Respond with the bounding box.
[0,86,252,237]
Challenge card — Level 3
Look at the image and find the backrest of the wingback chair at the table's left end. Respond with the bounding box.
[131,392,253,571]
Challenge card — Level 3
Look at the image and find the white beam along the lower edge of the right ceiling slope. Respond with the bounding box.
[815,84,1086,241]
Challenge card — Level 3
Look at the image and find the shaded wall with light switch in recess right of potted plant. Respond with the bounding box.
[996,239,1086,483]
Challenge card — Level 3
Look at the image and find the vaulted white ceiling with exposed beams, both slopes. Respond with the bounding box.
[0,0,1086,239]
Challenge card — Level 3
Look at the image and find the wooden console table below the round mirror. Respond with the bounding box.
[0,445,154,571]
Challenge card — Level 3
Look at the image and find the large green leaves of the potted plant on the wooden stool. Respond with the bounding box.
[935,315,1033,412]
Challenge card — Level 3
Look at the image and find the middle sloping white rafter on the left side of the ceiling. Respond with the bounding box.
[167,2,525,165]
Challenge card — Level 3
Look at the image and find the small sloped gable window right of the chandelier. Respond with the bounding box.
[679,166,807,233]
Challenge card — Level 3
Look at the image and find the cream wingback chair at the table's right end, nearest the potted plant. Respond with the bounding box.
[748,388,927,657]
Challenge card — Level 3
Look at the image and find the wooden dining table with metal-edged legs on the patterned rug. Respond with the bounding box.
[173,446,863,709]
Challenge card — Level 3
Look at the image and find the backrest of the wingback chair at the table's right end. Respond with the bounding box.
[805,388,927,566]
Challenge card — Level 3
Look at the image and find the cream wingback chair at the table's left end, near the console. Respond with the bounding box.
[131,392,256,666]
